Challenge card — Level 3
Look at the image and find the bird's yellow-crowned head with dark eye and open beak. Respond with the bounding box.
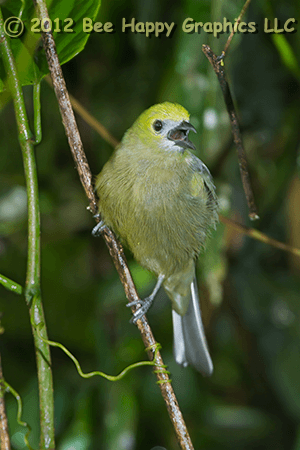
[128,102,196,152]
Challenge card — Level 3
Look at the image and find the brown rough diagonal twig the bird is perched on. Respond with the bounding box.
[37,0,194,450]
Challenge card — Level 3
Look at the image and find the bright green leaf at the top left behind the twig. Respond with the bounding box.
[0,0,101,91]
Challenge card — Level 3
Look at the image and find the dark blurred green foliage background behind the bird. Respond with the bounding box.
[0,0,300,450]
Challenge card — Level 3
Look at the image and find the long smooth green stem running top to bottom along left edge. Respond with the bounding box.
[0,8,55,449]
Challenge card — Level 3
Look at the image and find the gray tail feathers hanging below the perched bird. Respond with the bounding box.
[172,278,214,376]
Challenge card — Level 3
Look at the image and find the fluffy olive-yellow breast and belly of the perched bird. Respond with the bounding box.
[100,152,212,274]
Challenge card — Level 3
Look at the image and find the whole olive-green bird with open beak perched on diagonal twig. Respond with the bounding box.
[93,102,218,376]
